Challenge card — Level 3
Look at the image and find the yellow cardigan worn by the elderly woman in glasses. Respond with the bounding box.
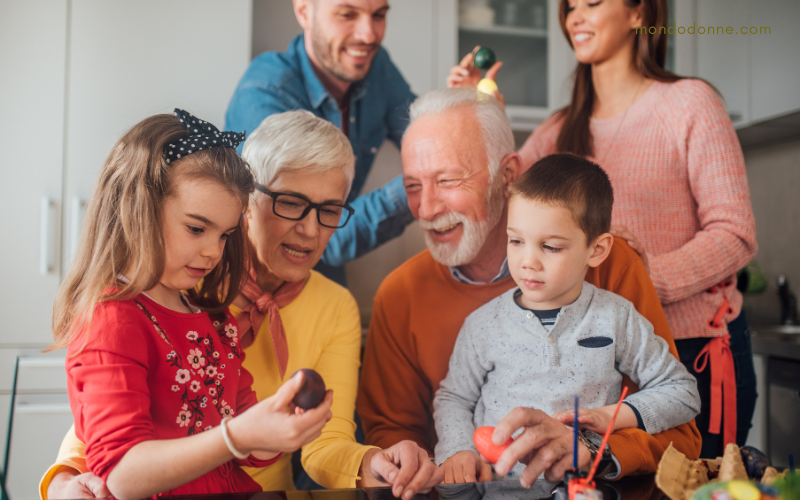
[39,271,373,500]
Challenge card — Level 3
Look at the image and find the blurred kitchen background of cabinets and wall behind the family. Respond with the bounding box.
[0,0,800,500]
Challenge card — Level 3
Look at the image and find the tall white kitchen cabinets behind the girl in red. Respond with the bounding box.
[0,0,252,498]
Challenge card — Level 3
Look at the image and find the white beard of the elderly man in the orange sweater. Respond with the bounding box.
[419,175,503,267]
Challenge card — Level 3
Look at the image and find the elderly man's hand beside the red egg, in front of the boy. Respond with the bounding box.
[492,408,591,488]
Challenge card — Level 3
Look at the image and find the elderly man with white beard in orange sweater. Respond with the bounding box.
[357,89,700,487]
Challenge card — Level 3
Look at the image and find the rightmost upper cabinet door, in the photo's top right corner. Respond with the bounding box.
[747,0,800,121]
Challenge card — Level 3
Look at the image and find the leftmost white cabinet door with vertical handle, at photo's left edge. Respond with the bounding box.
[0,0,67,345]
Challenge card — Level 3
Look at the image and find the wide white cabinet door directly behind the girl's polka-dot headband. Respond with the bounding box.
[64,0,252,274]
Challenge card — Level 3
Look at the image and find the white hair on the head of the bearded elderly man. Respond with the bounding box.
[409,88,514,180]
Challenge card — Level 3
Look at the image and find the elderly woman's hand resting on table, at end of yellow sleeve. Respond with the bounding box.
[358,440,444,500]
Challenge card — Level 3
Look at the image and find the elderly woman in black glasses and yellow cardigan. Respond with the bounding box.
[40,111,443,499]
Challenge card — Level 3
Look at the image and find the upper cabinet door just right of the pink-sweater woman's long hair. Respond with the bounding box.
[696,0,753,128]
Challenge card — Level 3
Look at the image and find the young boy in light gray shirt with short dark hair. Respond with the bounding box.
[433,154,700,482]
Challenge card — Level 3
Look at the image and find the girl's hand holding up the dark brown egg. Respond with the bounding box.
[228,374,333,459]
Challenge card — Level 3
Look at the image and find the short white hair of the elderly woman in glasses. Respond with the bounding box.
[242,110,356,193]
